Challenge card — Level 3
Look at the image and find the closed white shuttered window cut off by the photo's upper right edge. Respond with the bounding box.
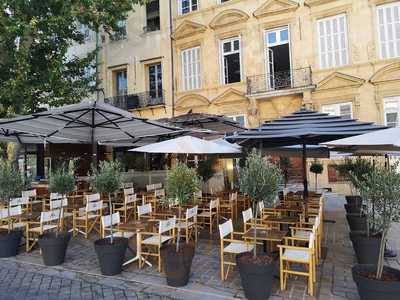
[377,1,400,59]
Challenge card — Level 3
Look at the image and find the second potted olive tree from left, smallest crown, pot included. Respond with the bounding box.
[38,167,75,266]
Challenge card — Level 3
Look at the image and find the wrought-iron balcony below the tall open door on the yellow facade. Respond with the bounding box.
[247,67,313,97]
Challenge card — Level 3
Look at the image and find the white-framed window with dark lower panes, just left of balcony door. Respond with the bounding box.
[221,37,242,84]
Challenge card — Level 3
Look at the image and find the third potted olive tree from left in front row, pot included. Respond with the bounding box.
[90,161,128,276]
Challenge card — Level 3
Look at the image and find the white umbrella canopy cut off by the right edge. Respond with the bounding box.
[324,127,400,154]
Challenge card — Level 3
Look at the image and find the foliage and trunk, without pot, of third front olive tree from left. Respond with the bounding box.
[89,161,122,244]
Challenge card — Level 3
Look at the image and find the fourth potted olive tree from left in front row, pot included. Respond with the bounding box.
[162,163,201,287]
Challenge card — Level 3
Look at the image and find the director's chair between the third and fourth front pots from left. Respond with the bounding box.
[139,217,176,272]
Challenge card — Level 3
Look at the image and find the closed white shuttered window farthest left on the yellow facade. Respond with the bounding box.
[182,47,201,91]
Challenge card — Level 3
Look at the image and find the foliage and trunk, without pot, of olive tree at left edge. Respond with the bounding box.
[0,159,24,232]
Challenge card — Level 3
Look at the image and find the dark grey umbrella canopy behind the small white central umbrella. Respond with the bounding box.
[159,112,243,134]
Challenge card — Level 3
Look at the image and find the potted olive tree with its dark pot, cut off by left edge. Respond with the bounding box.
[0,160,23,257]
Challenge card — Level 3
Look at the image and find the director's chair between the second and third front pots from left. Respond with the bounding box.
[73,200,103,238]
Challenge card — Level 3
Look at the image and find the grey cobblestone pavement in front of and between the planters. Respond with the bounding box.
[0,193,400,300]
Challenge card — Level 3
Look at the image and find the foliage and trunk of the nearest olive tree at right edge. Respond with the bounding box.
[350,164,400,279]
